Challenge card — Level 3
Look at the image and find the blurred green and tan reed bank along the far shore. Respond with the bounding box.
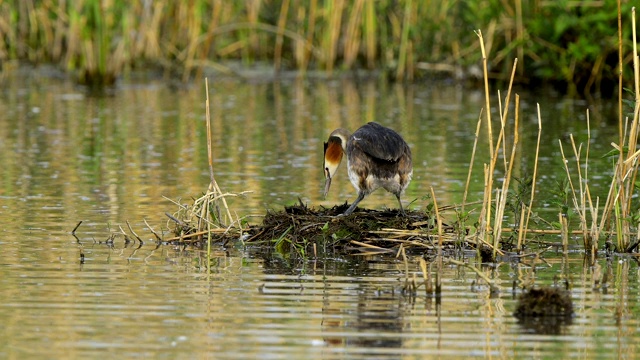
[0,0,633,92]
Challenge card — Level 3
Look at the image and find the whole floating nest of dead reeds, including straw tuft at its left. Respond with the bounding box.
[165,195,487,254]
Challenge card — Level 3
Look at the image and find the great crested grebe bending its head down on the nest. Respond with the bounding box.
[324,122,413,215]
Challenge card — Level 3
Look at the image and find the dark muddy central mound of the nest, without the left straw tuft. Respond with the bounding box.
[246,202,462,253]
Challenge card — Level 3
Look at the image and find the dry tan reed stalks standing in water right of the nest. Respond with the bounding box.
[458,8,640,264]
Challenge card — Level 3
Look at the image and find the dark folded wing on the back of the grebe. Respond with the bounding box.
[351,122,410,161]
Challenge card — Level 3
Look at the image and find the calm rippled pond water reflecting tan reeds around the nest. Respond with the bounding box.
[0,69,640,359]
